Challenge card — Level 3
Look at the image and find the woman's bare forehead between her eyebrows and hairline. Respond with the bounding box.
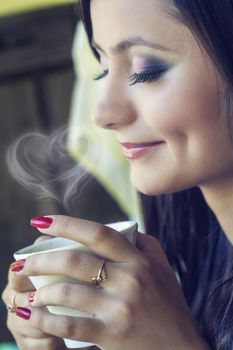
[91,0,194,55]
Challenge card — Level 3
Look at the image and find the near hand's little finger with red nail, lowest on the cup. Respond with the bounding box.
[18,309,104,344]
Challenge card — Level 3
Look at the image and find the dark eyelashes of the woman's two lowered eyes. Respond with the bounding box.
[94,68,167,86]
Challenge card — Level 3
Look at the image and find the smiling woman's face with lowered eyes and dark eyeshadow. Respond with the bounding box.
[91,0,233,194]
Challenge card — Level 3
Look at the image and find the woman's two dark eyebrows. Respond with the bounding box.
[92,37,174,53]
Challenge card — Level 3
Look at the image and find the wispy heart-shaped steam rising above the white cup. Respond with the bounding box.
[6,128,97,209]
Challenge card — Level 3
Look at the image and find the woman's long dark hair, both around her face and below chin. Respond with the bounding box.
[81,0,233,350]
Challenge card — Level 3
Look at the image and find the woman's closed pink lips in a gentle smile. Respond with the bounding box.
[121,141,164,159]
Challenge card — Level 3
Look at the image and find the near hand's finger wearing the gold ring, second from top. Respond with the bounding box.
[17,250,118,283]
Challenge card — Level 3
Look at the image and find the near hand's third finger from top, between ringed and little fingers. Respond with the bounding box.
[28,283,108,318]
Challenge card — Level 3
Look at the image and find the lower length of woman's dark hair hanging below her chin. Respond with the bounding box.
[142,188,233,350]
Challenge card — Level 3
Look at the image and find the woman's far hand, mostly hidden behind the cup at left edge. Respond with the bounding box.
[2,238,66,350]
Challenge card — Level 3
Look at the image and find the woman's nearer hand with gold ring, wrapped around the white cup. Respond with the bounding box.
[10,216,208,350]
